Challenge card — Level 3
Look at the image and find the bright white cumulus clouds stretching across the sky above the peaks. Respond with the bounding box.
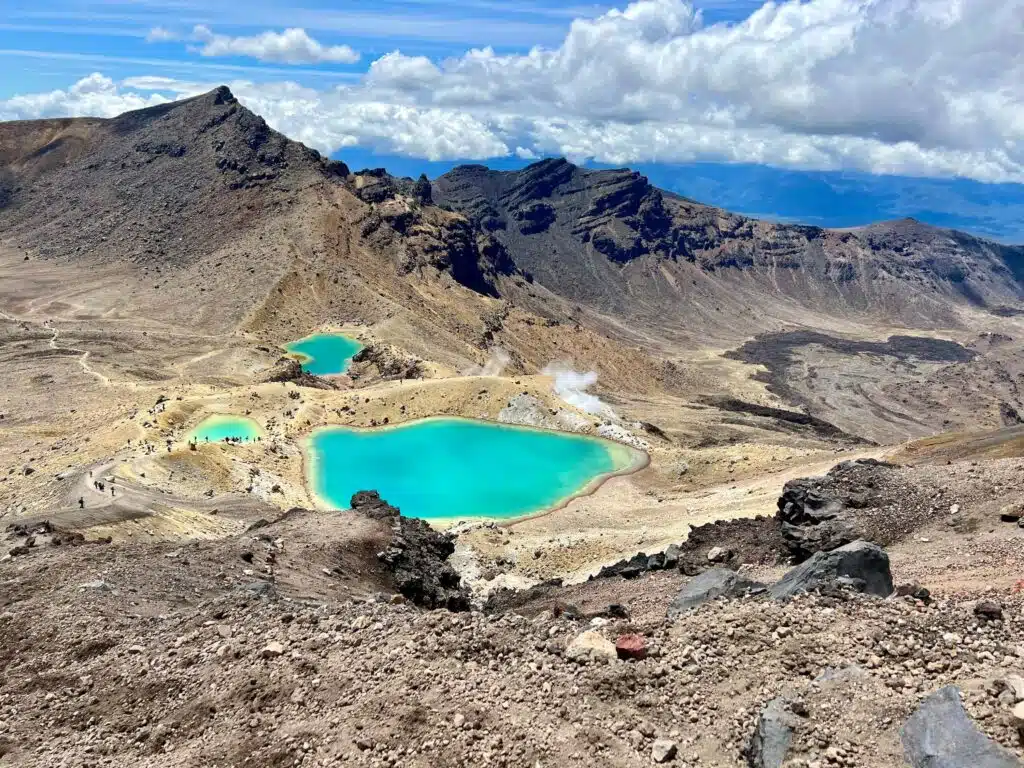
[0,0,1024,182]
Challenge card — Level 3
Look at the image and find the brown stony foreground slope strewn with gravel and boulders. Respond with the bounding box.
[0,464,1024,768]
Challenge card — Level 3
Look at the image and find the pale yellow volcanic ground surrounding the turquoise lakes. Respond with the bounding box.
[0,245,962,578]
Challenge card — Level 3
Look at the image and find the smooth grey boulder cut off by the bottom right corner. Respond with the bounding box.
[900,685,1024,768]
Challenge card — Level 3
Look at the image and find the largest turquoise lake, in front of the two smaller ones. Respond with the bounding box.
[307,418,646,520]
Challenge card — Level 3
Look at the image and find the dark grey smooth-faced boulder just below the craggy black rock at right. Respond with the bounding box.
[768,541,893,600]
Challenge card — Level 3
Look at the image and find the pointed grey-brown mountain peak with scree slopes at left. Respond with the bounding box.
[0,86,347,267]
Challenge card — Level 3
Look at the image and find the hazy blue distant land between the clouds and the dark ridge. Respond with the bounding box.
[339,150,1024,244]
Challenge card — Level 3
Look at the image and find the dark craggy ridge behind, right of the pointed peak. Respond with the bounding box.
[433,160,1024,335]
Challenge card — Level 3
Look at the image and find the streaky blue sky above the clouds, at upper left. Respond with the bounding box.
[0,0,761,98]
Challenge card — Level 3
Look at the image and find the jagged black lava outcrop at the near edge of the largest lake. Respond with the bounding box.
[351,490,469,610]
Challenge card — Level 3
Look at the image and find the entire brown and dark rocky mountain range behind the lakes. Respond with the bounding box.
[6,87,1024,348]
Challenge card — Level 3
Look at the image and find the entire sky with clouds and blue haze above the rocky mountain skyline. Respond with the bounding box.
[0,0,1024,242]
